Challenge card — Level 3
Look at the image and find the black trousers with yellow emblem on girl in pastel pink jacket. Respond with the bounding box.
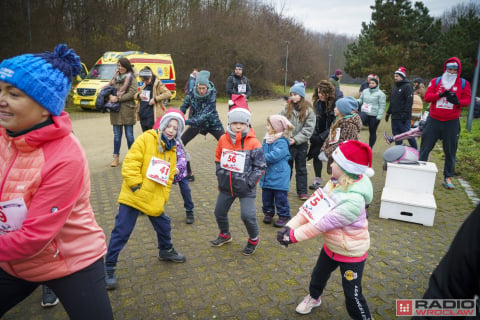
[309,249,371,319]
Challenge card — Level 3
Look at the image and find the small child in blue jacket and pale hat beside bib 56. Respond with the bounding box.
[260,115,294,228]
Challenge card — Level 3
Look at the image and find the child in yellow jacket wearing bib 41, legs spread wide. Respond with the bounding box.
[105,109,185,289]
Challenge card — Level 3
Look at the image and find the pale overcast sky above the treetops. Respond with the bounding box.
[270,0,462,36]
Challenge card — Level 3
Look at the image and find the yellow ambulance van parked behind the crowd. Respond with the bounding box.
[73,51,177,110]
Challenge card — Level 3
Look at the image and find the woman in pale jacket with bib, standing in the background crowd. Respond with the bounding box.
[357,78,386,148]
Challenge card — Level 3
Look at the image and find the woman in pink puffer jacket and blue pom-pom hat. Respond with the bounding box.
[0,44,113,319]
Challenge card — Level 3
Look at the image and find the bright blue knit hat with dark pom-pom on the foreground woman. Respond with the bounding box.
[0,44,82,116]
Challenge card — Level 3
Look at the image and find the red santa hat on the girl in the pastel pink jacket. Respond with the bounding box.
[332,140,375,177]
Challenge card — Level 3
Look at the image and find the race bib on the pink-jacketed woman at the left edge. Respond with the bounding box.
[0,198,28,234]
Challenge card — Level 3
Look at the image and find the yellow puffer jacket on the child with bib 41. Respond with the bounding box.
[118,129,177,216]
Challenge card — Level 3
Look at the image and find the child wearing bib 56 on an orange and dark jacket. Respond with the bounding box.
[211,95,267,255]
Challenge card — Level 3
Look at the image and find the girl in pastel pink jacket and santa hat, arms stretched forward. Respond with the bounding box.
[277,140,374,319]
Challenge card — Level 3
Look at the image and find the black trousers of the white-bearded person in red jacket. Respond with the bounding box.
[420,117,460,178]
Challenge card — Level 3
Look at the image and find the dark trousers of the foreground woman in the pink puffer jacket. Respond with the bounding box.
[0,259,113,320]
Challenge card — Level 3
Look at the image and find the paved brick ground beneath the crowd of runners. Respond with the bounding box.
[4,95,473,320]
